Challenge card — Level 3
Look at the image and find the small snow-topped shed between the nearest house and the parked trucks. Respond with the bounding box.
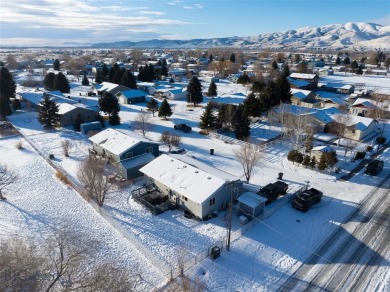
[237,192,267,218]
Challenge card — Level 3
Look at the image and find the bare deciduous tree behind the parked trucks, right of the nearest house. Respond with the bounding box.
[234,143,264,182]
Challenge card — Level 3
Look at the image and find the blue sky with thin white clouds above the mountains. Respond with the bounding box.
[0,0,390,46]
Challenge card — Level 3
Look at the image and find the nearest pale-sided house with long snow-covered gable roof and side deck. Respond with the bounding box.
[140,154,242,219]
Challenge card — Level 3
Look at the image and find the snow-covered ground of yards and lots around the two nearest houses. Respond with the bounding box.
[0,76,390,291]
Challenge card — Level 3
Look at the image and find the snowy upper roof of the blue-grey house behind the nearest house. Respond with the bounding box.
[89,129,152,155]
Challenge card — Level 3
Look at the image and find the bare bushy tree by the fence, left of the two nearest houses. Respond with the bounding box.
[77,156,112,207]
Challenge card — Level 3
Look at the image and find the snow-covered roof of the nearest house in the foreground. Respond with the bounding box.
[140,154,230,204]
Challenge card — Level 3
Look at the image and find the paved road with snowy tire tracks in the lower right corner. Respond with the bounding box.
[278,174,390,292]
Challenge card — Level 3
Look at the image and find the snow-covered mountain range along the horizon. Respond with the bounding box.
[92,22,390,51]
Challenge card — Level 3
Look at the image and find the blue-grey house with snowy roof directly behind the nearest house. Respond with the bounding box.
[89,129,159,179]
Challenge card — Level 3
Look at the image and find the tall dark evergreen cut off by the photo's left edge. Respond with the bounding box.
[0,67,16,119]
